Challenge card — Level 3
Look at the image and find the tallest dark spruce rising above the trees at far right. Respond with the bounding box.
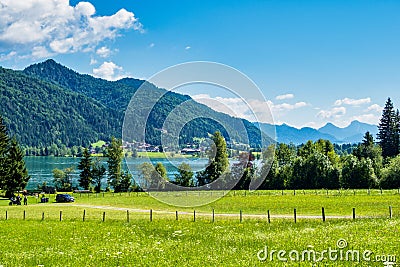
[377,98,399,158]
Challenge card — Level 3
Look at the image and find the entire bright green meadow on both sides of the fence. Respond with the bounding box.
[0,190,400,266]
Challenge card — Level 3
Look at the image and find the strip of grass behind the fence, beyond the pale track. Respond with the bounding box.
[12,190,400,216]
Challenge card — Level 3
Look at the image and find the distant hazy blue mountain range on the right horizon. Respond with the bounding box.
[255,120,378,144]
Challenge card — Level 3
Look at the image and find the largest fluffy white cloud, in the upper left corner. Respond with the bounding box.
[0,0,143,58]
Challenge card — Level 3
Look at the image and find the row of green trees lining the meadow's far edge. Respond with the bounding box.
[71,103,400,192]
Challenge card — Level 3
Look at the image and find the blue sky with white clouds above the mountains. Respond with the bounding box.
[0,0,400,127]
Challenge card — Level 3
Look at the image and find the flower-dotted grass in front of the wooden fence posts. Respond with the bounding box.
[0,219,400,266]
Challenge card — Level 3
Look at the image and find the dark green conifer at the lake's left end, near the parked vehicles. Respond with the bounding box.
[3,138,30,197]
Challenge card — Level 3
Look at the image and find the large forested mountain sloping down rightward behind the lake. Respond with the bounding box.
[0,60,270,147]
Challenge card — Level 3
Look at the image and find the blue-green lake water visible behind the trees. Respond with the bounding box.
[25,157,208,190]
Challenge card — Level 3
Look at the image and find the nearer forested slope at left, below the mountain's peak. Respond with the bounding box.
[0,68,121,146]
